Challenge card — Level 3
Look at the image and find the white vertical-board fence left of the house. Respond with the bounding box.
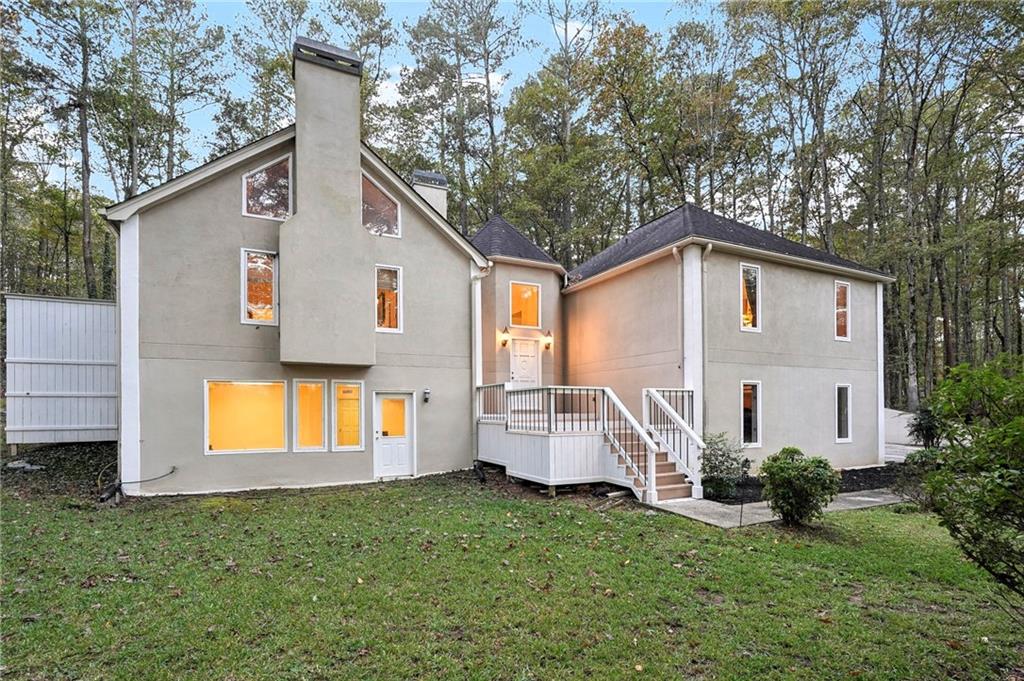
[4,294,118,444]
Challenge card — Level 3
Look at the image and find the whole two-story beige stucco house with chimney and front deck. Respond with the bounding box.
[99,39,888,502]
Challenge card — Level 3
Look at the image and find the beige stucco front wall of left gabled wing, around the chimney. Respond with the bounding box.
[131,145,472,494]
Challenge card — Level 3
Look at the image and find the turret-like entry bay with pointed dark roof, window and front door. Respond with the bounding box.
[472,215,565,388]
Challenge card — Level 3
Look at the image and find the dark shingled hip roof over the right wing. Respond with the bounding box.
[569,204,891,286]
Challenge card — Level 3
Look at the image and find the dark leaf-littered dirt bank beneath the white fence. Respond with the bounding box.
[0,442,118,501]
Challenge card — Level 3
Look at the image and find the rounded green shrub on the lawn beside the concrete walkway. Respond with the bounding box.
[761,446,840,525]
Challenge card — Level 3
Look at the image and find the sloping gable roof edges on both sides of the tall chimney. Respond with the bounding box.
[102,124,487,267]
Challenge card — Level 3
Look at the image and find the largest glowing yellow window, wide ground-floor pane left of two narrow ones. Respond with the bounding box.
[206,381,285,452]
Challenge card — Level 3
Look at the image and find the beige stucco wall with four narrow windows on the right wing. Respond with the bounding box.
[703,251,878,467]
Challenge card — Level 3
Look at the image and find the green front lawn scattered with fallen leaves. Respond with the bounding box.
[0,446,1022,679]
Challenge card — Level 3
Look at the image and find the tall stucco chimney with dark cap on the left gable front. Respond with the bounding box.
[279,38,376,366]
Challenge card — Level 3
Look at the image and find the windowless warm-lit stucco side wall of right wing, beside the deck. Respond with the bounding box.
[562,250,682,409]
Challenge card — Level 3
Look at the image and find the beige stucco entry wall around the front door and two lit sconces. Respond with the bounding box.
[480,262,565,385]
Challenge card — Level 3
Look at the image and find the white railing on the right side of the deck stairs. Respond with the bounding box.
[643,388,706,499]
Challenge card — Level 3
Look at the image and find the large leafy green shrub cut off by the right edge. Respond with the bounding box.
[927,355,1024,620]
